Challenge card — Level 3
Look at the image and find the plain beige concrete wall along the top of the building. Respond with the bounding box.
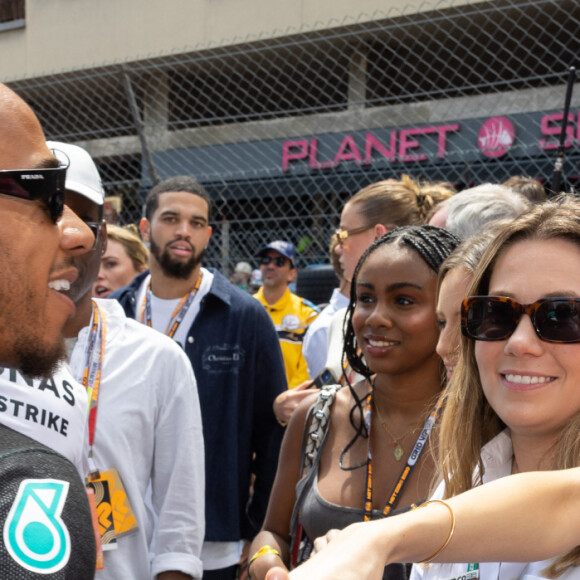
[0,0,480,82]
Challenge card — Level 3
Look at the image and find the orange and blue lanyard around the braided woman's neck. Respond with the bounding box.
[364,386,445,522]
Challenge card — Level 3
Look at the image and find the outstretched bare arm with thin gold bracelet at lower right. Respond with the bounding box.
[266,468,580,580]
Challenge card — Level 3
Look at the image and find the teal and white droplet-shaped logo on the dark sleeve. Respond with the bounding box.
[4,479,71,574]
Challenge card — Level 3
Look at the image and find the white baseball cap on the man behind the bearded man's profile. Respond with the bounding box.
[46,141,105,205]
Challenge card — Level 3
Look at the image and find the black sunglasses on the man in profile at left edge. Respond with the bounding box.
[0,166,66,223]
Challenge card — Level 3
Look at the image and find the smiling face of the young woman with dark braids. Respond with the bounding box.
[352,244,438,374]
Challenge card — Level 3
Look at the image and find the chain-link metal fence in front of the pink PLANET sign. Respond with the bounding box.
[9,0,580,270]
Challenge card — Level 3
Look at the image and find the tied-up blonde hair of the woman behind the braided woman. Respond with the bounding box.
[347,174,455,229]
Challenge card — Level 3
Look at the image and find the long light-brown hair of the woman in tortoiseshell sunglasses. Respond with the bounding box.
[436,196,580,578]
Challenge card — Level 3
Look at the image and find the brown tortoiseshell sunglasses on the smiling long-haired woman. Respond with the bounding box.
[461,296,580,343]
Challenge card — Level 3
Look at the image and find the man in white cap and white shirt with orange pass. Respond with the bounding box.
[42,142,204,580]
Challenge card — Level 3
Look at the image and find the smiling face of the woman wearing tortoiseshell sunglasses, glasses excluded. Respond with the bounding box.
[475,239,580,436]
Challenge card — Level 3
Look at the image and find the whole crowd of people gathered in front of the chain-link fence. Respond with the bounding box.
[0,78,580,580]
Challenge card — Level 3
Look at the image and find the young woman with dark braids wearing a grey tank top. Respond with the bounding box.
[249,226,459,580]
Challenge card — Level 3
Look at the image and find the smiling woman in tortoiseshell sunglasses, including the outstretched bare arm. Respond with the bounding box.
[278,200,580,580]
